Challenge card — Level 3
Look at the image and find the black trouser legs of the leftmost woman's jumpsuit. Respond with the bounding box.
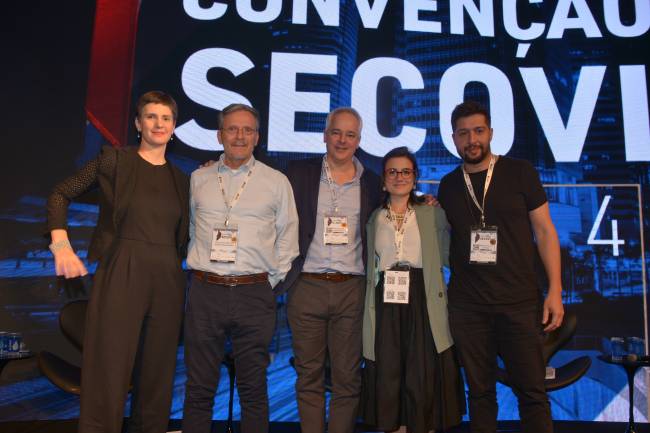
[79,239,186,433]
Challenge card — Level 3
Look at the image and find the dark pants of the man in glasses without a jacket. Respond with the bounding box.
[183,278,275,433]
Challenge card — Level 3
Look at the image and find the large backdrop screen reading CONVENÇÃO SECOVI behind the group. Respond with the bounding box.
[0,0,650,420]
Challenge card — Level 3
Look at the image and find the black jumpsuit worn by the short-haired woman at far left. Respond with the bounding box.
[79,156,185,433]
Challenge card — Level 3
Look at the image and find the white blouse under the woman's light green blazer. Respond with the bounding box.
[375,209,422,270]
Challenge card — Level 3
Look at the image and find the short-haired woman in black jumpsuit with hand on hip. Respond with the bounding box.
[48,92,189,433]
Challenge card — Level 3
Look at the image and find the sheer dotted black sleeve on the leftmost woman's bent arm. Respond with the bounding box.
[47,146,117,232]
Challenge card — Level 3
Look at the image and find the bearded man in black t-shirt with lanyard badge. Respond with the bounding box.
[438,101,564,433]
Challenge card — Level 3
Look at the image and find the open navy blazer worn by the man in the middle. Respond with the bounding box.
[276,157,381,293]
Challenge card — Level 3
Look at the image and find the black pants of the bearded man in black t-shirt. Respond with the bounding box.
[449,306,553,433]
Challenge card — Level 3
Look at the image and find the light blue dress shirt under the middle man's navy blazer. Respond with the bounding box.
[302,157,365,275]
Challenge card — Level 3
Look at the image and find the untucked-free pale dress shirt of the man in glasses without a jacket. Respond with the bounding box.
[187,155,298,287]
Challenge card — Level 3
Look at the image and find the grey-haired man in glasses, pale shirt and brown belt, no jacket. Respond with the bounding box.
[183,104,298,433]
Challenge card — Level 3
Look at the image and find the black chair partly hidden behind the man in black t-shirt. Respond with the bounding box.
[497,312,591,391]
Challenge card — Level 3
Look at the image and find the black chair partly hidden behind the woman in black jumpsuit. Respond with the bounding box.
[38,300,88,395]
